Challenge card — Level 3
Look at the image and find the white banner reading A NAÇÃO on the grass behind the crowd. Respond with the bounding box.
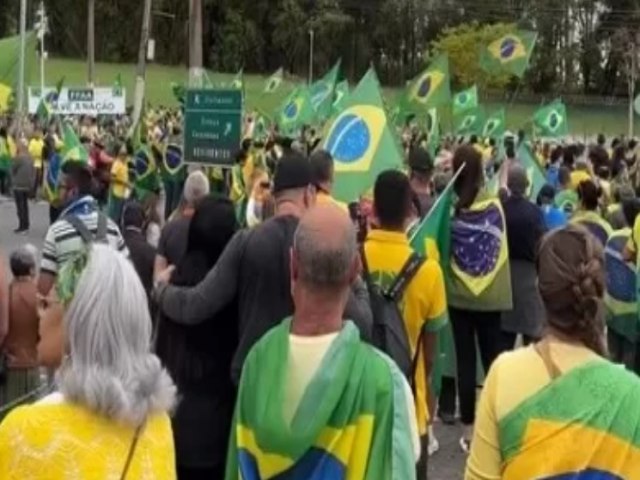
[29,87,127,116]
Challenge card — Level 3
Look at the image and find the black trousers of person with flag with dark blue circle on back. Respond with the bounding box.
[449,307,504,425]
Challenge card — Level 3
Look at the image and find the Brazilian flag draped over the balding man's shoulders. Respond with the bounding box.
[225,320,415,480]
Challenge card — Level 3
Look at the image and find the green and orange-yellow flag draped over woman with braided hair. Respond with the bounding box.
[498,360,640,480]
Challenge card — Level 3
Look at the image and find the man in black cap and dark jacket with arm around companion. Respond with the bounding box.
[155,151,372,384]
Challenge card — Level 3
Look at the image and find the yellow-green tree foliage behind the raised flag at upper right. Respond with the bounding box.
[431,22,516,91]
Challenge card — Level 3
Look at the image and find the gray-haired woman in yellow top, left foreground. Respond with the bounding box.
[0,244,176,480]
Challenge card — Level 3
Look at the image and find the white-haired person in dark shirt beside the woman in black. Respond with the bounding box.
[154,170,209,280]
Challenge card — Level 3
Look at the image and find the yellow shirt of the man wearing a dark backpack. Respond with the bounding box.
[364,230,447,435]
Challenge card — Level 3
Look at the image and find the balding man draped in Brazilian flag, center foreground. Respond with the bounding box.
[227,204,420,480]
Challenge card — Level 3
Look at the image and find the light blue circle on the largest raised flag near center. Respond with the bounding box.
[327,114,371,163]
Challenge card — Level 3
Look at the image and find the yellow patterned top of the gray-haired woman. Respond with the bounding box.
[0,400,176,480]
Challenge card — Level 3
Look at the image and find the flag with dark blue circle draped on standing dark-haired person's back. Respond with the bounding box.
[446,191,513,312]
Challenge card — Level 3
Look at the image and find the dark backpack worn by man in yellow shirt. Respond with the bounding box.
[361,247,425,388]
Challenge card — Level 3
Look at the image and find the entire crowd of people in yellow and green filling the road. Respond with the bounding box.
[0,109,640,480]
